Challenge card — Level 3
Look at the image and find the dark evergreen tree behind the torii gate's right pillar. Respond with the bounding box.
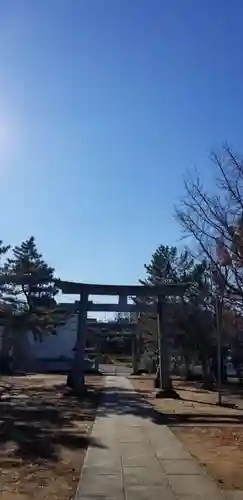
[139,245,213,380]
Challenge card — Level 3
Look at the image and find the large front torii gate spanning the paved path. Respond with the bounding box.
[56,280,189,390]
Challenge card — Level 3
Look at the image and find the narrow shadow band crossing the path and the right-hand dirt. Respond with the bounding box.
[96,387,243,426]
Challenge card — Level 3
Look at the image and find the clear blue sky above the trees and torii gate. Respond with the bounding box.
[0,0,243,283]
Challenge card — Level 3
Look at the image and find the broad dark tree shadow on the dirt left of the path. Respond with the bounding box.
[0,384,103,467]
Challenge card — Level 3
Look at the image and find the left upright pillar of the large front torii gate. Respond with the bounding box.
[73,294,88,390]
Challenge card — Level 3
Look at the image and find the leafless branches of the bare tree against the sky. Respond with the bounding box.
[175,146,243,306]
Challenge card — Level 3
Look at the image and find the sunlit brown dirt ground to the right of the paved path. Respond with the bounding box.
[130,376,243,490]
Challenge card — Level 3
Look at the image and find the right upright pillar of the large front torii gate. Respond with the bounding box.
[157,296,171,391]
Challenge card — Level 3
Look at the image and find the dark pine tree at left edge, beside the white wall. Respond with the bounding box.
[3,236,66,370]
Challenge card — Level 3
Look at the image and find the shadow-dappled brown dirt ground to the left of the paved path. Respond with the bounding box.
[0,375,103,500]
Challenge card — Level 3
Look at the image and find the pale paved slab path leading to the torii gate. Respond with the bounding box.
[75,376,228,500]
